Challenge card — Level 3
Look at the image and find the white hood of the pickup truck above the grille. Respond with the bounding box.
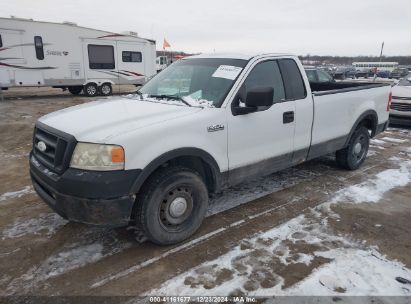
[39,97,201,143]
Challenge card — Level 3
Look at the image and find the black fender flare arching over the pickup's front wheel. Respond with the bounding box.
[131,148,222,193]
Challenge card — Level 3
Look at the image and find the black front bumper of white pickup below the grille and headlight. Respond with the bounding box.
[30,155,141,227]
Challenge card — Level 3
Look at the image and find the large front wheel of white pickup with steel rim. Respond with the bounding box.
[135,166,208,245]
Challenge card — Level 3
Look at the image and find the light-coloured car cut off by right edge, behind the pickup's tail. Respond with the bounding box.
[390,74,411,125]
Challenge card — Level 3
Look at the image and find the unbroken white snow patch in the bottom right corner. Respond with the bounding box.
[284,248,411,296]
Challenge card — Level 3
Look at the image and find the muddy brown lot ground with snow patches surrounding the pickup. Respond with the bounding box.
[0,90,411,296]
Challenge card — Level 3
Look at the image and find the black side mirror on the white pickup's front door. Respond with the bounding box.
[232,87,274,116]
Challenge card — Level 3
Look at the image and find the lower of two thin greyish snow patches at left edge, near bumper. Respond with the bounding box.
[2,213,68,239]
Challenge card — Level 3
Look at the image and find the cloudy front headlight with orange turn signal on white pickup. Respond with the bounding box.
[70,143,124,171]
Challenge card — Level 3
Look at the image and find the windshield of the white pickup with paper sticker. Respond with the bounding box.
[140,58,247,107]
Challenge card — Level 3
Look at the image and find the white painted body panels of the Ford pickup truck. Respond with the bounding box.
[40,54,390,172]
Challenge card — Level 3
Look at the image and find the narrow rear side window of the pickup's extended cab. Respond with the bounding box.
[279,59,306,100]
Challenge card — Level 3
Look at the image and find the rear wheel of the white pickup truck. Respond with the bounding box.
[335,126,370,170]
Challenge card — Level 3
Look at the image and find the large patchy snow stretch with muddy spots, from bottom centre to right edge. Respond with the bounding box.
[147,161,411,296]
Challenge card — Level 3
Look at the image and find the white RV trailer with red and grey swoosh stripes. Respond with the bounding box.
[0,18,156,96]
